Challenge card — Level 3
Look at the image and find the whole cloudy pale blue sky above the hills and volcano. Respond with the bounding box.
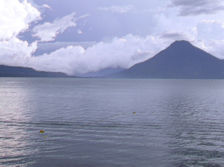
[0,0,224,75]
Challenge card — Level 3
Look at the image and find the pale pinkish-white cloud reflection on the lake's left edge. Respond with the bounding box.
[0,79,34,166]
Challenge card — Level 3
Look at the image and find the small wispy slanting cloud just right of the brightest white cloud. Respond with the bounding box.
[33,13,78,42]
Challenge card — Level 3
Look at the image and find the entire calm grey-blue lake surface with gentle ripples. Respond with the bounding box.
[0,78,224,167]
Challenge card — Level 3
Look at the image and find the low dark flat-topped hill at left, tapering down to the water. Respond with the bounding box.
[0,65,68,77]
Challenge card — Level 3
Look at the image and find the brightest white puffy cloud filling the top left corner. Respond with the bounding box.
[0,0,41,40]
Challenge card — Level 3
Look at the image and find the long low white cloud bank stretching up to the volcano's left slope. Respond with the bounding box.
[29,35,169,75]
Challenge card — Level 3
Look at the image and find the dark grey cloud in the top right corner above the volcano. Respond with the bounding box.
[170,0,224,16]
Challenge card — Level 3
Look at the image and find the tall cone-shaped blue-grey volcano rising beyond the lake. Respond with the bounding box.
[115,41,224,79]
